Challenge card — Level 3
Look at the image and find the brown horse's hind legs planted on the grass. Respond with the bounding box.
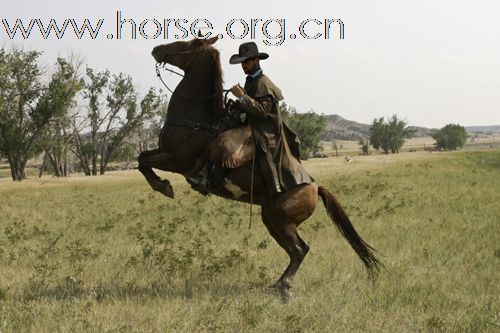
[262,207,309,300]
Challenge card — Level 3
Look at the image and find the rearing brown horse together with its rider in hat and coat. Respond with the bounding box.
[138,36,381,299]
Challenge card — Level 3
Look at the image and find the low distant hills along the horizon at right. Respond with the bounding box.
[322,114,500,141]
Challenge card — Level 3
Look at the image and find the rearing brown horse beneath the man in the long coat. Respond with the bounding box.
[139,37,380,298]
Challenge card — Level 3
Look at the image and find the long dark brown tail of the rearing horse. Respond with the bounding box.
[318,186,382,280]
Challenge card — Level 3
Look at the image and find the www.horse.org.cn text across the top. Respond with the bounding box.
[0,11,344,46]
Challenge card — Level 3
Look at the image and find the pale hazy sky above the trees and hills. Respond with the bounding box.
[0,0,500,128]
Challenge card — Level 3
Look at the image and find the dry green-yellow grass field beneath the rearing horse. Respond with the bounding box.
[0,150,500,332]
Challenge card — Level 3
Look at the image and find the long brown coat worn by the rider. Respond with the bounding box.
[239,73,314,194]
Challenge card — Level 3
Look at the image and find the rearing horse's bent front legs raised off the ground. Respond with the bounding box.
[138,149,174,199]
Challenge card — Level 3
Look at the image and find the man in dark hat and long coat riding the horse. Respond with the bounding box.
[188,42,314,195]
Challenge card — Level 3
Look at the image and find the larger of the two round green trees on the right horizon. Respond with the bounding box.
[369,115,414,154]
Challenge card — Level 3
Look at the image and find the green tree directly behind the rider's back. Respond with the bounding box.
[280,103,327,159]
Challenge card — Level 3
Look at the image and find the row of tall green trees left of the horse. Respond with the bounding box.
[0,49,167,181]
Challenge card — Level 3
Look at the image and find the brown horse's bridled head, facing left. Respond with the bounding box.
[151,36,219,71]
